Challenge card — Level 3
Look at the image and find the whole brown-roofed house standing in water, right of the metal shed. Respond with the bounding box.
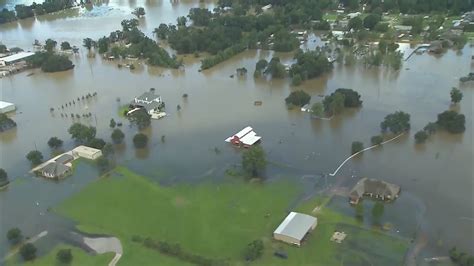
[349,177,401,204]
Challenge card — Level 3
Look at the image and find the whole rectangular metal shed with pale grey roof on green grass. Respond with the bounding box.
[273,212,318,246]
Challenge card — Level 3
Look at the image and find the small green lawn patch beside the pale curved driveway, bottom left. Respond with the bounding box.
[6,245,114,266]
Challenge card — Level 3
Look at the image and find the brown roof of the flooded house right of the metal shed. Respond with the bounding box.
[350,177,400,198]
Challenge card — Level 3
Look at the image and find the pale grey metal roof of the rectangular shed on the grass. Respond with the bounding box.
[273,212,317,241]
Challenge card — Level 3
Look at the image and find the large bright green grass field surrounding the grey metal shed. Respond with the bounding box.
[56,167,408,265]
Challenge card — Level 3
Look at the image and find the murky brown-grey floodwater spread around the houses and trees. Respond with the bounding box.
[0,1,474,262]
